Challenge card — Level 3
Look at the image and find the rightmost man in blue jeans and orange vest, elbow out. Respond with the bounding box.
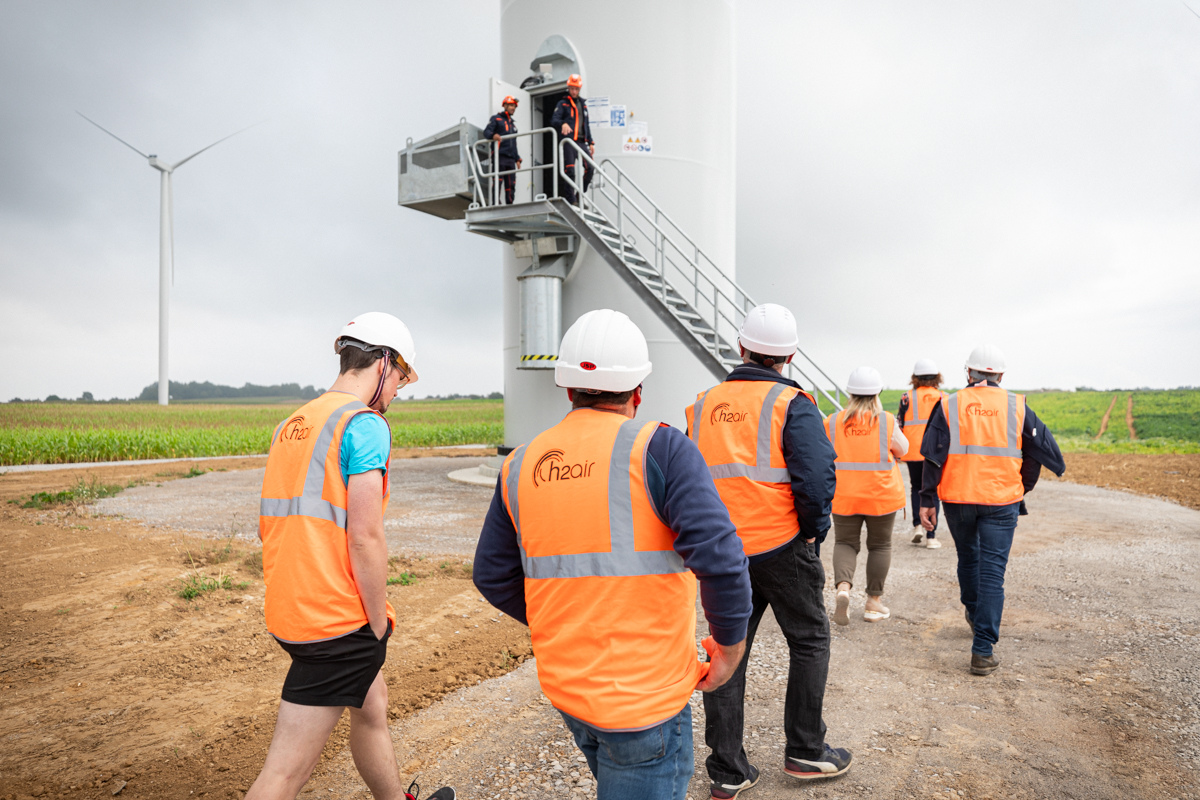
[920,344,1067,675]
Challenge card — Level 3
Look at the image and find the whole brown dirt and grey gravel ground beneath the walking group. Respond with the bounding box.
[0,451,1200,800]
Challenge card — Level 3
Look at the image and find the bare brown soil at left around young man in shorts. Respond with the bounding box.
[0,451,530,799]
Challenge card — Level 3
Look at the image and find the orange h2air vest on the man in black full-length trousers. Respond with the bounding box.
[684,380,816,555]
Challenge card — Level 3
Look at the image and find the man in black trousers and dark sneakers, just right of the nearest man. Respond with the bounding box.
[684,303,851,799]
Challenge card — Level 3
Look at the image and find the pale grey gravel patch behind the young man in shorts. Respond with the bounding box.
[96,457,492,558]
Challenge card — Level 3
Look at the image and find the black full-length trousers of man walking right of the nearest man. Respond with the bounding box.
[704,536,829,783]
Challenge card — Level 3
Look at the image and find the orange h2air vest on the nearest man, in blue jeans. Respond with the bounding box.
[500,409,706,730]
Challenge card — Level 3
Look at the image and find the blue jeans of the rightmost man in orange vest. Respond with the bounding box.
[942,503,1021,656]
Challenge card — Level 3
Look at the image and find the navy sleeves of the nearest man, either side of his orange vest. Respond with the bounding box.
[473,425,751,645]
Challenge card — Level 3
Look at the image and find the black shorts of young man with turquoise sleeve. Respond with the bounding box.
[276,620,391,709]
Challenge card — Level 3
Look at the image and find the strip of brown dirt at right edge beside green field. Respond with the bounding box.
[1056,453,1200,509]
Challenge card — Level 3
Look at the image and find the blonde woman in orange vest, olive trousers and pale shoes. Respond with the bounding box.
[826,367,908,625]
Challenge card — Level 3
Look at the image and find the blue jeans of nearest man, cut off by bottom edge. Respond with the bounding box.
[559,705,695,800]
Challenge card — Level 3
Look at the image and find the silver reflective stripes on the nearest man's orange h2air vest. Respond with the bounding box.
[506,420,688,581]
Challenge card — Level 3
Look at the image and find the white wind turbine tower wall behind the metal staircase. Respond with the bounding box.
[500,0,736,447]
